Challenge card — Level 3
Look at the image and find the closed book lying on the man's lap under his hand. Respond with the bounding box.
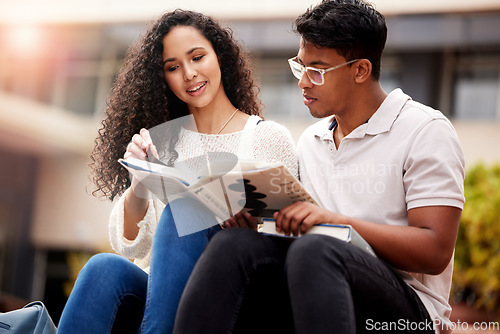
[259,218,377,257]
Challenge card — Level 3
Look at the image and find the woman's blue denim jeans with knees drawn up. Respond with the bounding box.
[58,200,221,334]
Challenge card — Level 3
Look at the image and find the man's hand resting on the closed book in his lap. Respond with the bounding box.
[274,202,342,236]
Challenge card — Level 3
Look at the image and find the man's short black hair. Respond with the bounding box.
[294,0,387,80]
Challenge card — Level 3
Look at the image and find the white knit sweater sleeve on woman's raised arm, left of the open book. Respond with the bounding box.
[109,188,165,262]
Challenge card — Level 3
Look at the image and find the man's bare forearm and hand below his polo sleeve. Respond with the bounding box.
[274,202,462,275]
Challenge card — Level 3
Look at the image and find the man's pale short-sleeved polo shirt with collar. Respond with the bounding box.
[297,89,465,328]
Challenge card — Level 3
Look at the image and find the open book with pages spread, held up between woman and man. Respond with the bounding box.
[119,158,317,221]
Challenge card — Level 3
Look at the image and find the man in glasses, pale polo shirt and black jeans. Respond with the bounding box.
[176,0,464,333]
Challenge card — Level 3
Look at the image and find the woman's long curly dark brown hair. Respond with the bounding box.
[89,9,261,200]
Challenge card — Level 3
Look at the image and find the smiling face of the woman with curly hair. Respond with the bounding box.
[162,26,225,108]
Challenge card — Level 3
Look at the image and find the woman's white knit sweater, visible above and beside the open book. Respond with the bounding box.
[109,116,298,271]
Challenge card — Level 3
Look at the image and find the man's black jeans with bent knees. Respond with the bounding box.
[174,228,434,334]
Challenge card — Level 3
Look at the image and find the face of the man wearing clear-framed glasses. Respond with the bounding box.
[297,40,355,118]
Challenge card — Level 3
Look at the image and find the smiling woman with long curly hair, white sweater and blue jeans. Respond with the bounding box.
[59,10,298,334]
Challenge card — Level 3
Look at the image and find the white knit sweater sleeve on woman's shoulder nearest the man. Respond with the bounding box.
[253,121,299,178]
